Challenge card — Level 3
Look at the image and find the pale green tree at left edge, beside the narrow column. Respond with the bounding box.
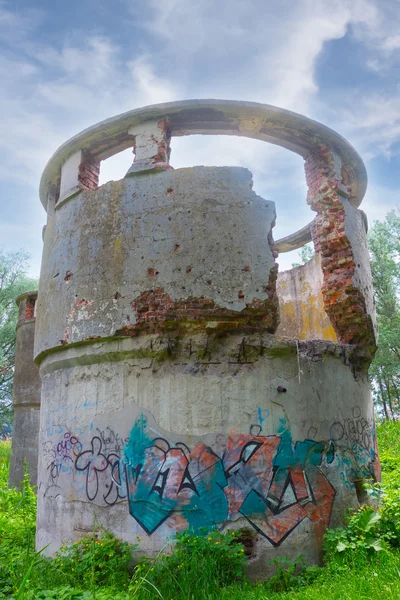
[0,249,38,438]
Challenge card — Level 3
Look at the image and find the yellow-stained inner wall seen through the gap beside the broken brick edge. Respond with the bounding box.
[276,254,337,342]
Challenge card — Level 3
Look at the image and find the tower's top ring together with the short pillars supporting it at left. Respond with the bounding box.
[40,100,367,252]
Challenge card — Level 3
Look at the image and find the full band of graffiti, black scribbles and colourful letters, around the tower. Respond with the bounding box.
[43,407,379,546]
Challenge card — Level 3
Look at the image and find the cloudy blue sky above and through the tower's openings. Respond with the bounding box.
[0,0,400,277]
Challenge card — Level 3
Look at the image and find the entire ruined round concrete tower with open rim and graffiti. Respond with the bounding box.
[35,100,379,577]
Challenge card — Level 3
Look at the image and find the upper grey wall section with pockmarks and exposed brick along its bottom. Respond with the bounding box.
[35,167,279,355]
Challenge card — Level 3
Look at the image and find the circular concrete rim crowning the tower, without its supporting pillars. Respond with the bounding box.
[39,100,367,252]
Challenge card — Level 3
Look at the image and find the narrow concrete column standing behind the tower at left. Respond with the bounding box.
[9,292,41,487]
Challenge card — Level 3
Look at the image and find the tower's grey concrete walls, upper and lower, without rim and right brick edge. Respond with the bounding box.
[35,165,379,577]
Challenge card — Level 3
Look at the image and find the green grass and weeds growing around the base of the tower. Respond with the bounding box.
[0,423,400,600]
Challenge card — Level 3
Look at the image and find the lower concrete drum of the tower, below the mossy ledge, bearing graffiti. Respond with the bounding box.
[37,334,379,578]
